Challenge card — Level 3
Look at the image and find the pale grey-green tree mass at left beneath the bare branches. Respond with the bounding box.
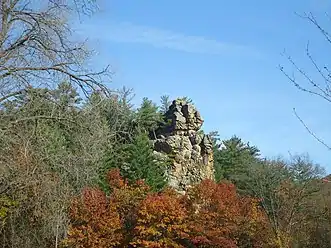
[0,82,112,247]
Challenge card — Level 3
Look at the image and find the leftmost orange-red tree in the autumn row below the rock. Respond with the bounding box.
[65,188,123,248]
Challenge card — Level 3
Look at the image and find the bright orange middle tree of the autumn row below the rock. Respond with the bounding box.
[131,191,188,247]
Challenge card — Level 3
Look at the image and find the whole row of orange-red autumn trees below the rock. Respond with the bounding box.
[63,170,268,248]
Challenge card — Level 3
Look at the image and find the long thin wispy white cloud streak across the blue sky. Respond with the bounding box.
[84,23,261,57]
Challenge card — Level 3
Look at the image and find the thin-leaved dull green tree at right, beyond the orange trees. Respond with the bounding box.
[244,156,323,247]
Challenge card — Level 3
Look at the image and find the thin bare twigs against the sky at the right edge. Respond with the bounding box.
[279,12,331,150]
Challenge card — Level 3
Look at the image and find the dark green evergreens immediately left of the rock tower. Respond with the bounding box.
[99,98,167,192]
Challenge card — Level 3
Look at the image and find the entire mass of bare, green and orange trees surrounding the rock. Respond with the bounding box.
[0,0,331,248]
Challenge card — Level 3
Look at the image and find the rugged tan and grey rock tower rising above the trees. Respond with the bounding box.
[153,100,214,192]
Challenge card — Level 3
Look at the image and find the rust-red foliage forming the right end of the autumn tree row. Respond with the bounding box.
[188,180,267,248]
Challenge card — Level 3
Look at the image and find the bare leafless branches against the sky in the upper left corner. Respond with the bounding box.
[0,0,108,104]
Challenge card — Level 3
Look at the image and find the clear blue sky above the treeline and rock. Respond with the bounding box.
[75,0,331,172]
